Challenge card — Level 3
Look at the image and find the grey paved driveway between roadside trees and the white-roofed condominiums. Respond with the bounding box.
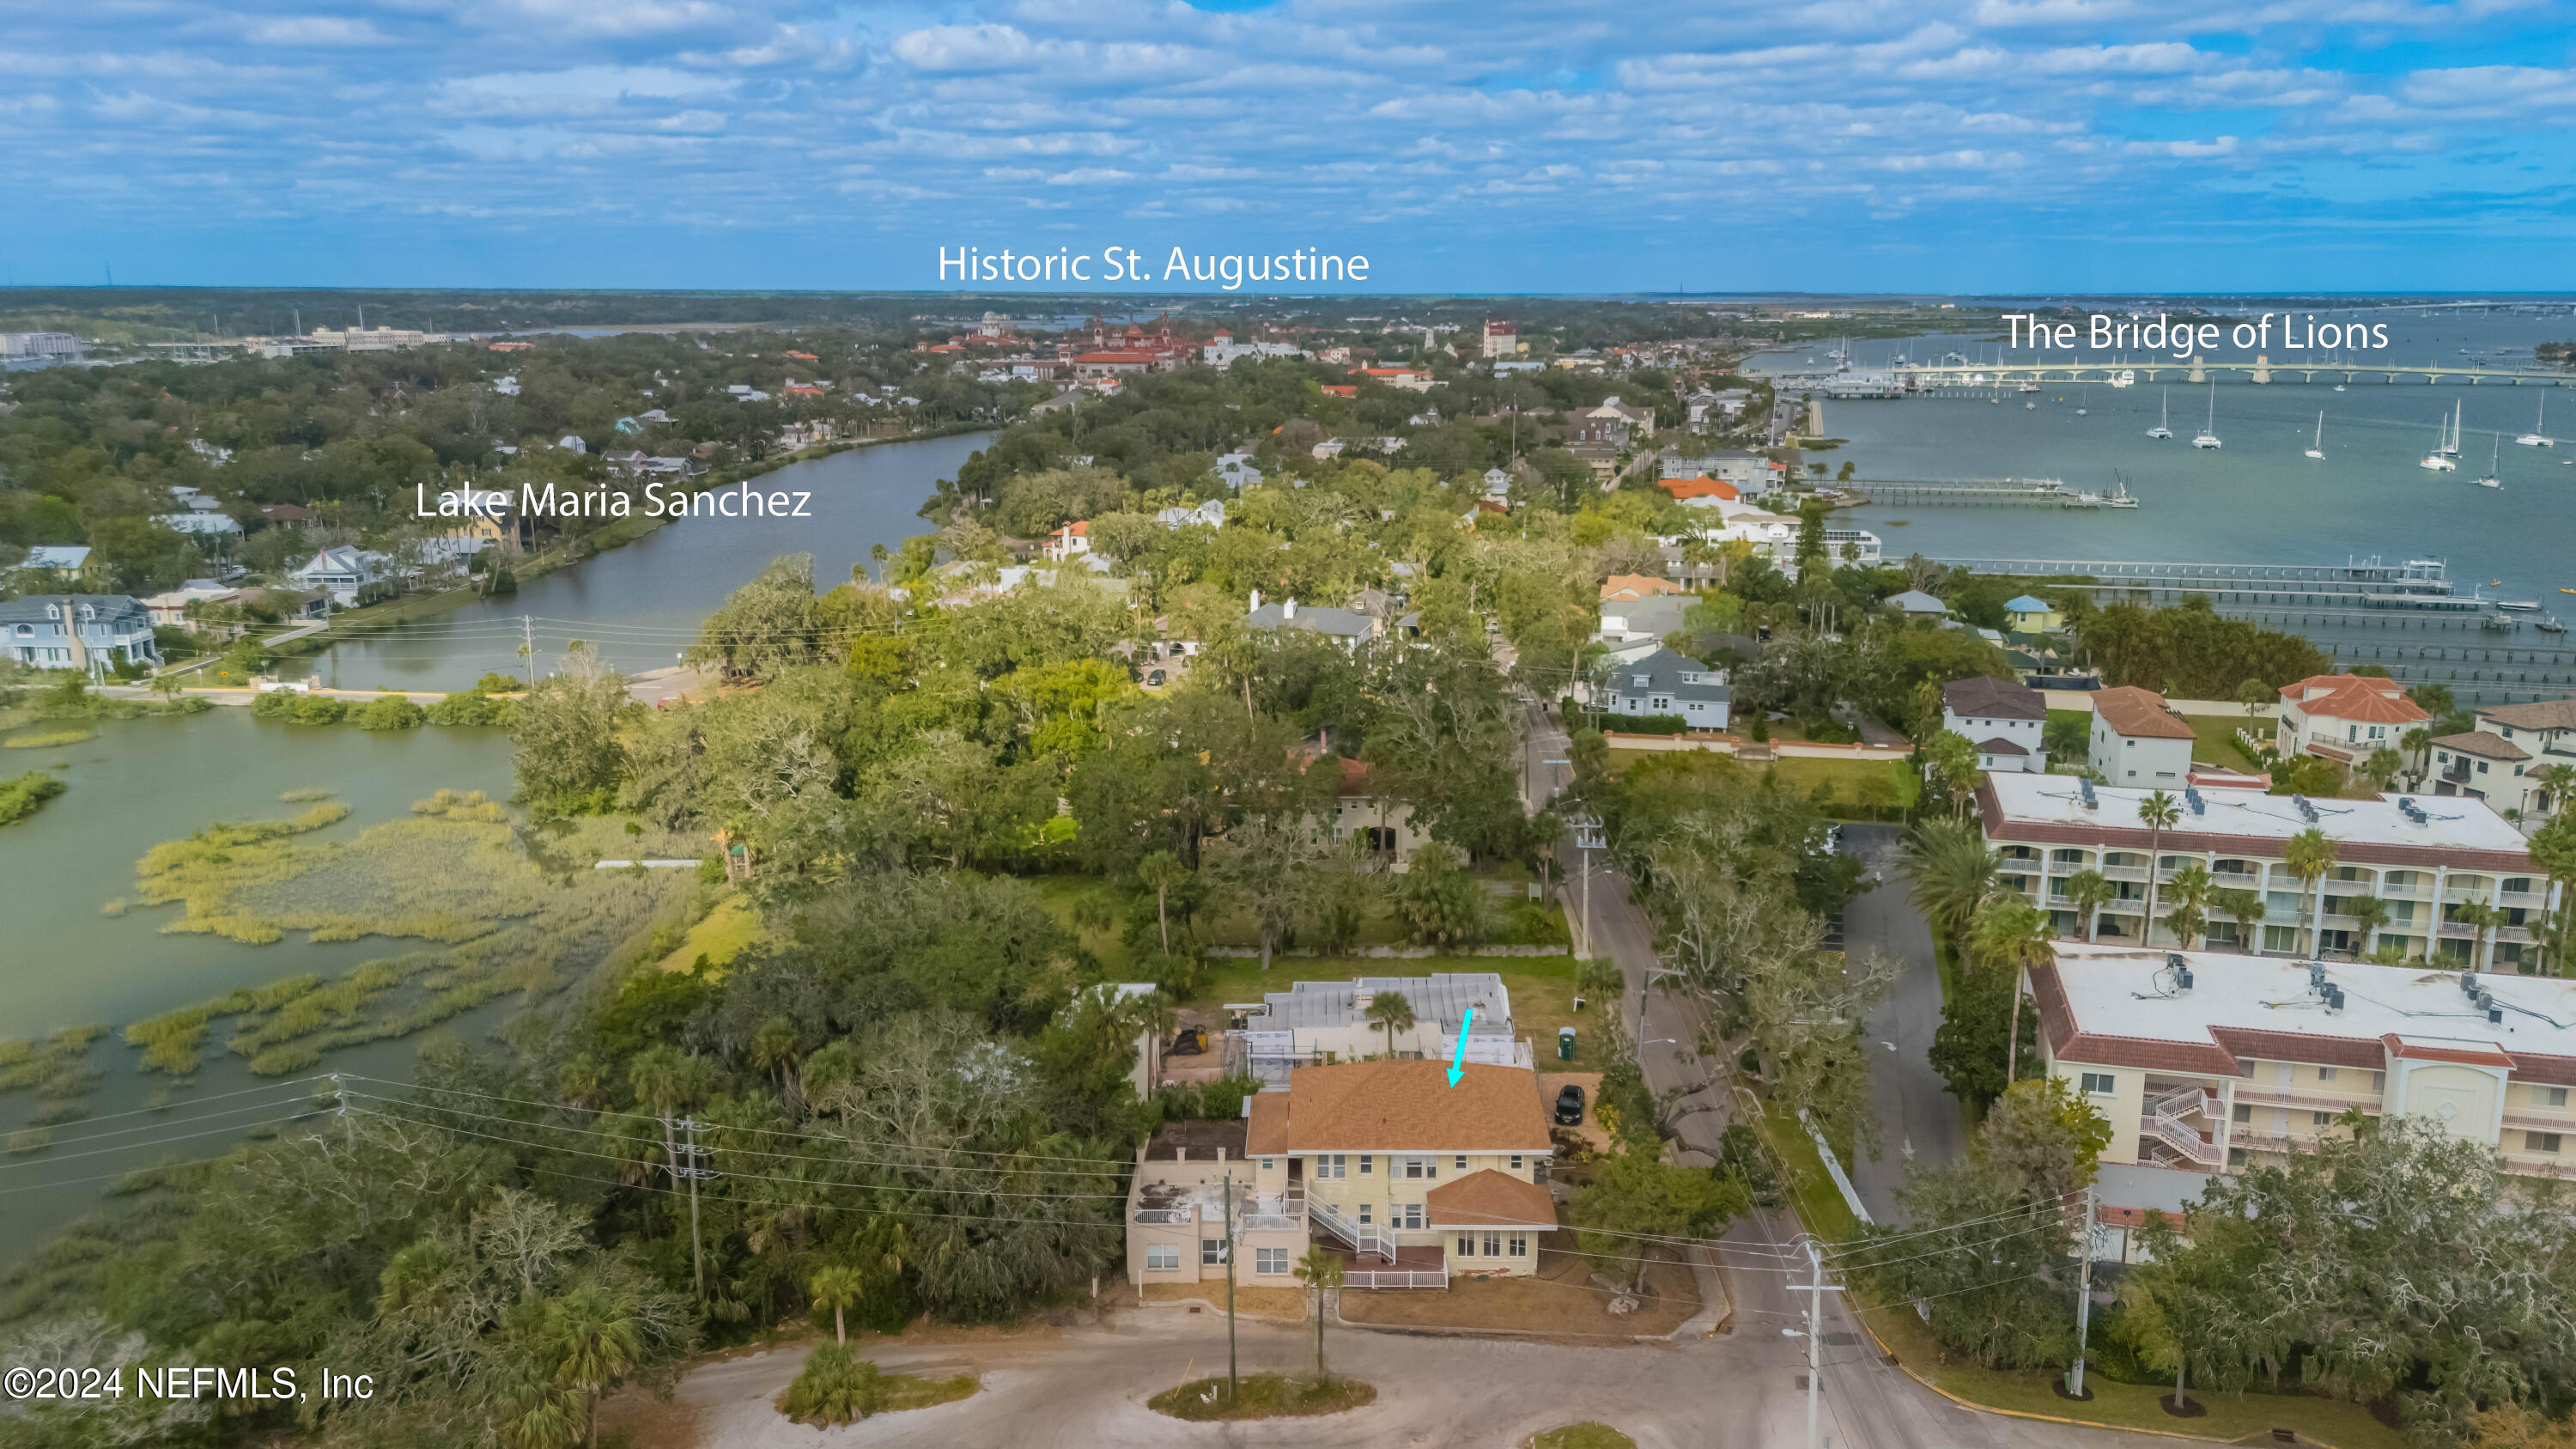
[1842,825,1968,1222]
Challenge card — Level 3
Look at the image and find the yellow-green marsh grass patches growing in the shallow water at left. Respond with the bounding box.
[125,789,698,1078]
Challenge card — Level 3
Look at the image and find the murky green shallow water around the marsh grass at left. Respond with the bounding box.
[0,709,510,1242]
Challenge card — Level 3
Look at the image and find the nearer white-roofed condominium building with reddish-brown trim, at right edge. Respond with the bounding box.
[2030,944,2576,1178]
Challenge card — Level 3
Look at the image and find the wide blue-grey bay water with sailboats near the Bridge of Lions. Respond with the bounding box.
[1759,312,2576,595]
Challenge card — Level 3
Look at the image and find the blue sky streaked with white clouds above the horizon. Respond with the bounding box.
[0,0,2576,291]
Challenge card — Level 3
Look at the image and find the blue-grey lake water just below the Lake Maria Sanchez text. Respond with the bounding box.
[287,433,992,688]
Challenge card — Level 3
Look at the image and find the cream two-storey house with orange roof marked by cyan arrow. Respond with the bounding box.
[1126,1057,1558,1289]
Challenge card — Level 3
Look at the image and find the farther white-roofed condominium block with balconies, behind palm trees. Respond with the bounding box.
[1976,774,2555,970]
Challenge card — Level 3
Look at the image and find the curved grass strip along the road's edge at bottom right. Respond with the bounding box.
[1862,1307,2403,1449]
